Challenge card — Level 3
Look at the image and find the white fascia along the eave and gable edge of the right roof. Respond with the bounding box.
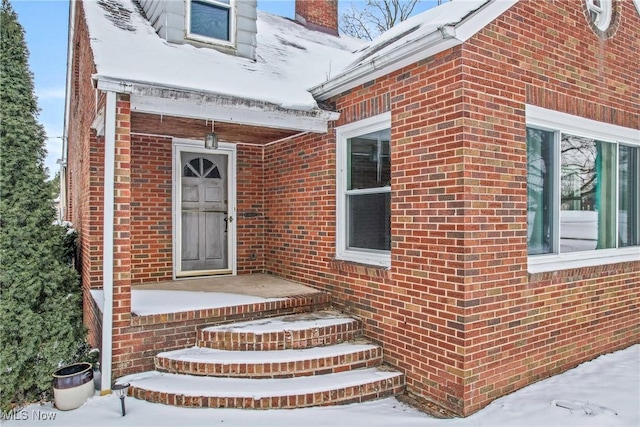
[309,0,520,100]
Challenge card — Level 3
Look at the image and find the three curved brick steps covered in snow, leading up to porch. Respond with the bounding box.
[123,311,405,409]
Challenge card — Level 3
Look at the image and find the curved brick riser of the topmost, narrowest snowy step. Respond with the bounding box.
[198,321,362,351]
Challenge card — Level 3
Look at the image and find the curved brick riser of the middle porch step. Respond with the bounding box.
[155,347,382,378]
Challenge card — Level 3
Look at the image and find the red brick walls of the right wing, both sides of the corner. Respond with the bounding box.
[265,0,640,415]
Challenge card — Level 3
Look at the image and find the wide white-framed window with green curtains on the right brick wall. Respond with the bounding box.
[527,106,640,270]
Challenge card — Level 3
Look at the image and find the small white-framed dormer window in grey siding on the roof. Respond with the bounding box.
[187,0,235,45]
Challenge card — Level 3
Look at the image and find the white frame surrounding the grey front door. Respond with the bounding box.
[171,138,237,279]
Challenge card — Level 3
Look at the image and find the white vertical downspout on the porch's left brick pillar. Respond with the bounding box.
[100,92,116,395]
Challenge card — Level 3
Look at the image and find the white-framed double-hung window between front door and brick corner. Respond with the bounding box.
[336,113,391,266]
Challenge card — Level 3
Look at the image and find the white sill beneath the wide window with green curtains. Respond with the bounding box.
[528,246,640,274]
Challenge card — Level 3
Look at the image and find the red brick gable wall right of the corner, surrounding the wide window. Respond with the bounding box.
[456,0,640,413]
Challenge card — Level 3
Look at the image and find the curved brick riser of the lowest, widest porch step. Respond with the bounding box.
[130,376,405,409]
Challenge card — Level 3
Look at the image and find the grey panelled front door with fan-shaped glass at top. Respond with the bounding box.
[176,151,233,276]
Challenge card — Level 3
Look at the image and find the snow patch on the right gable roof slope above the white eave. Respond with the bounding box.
[349,0,489,68]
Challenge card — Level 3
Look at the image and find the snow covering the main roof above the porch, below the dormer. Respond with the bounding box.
[83,0,362,111]
